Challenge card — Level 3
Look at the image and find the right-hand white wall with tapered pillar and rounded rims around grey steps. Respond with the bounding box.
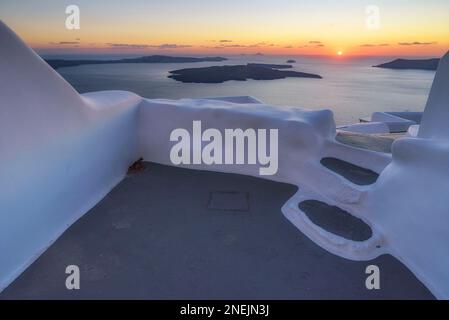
[283,54,449,299]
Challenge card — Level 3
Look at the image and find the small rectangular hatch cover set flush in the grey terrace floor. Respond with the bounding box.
[207,191,249,211]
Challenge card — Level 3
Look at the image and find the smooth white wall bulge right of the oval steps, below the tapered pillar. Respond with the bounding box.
[364,138,449,299]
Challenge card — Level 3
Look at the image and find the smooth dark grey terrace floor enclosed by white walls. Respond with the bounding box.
[0,163,433,299]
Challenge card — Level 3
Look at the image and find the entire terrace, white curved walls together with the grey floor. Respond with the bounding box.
[0,23,449,298]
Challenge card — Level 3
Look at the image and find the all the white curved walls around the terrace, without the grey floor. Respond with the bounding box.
[0,23,449,298]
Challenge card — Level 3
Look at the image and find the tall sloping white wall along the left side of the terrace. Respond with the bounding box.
[0,22,141,290]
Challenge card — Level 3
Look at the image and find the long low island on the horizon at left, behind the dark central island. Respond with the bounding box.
[45,55,227,69]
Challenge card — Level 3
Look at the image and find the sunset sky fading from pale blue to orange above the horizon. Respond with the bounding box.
[0,0,449,56]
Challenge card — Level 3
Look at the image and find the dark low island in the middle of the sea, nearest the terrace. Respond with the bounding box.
[168,63,322,83]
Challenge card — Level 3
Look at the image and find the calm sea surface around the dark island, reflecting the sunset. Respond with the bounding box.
[46,55,435,124]
